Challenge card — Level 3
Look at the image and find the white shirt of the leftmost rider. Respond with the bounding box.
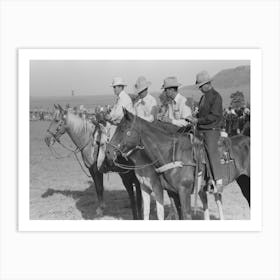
[110,91,134,123]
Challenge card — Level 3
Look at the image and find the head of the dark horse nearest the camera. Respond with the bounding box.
[106,109,141,161]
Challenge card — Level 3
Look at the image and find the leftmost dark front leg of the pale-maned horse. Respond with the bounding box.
[89,164,105,216]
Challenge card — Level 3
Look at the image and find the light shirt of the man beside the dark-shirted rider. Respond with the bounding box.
[168,93,192,120]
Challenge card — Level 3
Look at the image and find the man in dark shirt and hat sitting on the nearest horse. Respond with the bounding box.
[189,71,223,191]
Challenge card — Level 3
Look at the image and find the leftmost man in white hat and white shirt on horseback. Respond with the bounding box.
[109,77,134,123]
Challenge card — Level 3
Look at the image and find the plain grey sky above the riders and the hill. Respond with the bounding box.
[30,60,249,97]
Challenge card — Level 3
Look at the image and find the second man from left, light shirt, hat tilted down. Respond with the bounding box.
[134,76,157,122]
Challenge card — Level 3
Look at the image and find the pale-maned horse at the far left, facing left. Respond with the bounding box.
[45,105,142,220]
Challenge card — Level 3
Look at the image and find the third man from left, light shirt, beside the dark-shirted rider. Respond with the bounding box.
[162,77,191,127]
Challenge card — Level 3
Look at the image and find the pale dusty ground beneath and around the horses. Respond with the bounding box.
[30,122,250,220]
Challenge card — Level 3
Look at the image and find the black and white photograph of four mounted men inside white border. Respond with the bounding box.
[19,49,260,230]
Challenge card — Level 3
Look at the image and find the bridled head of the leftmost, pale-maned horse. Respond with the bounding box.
[45,104,67,146]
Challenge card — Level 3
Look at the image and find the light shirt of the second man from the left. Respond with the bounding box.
[134,93,157,122]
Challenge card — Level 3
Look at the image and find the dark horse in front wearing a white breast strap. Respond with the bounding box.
[106,110,250,219]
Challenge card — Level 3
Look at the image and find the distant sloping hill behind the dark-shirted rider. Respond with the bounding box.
[180,65,250,106]
